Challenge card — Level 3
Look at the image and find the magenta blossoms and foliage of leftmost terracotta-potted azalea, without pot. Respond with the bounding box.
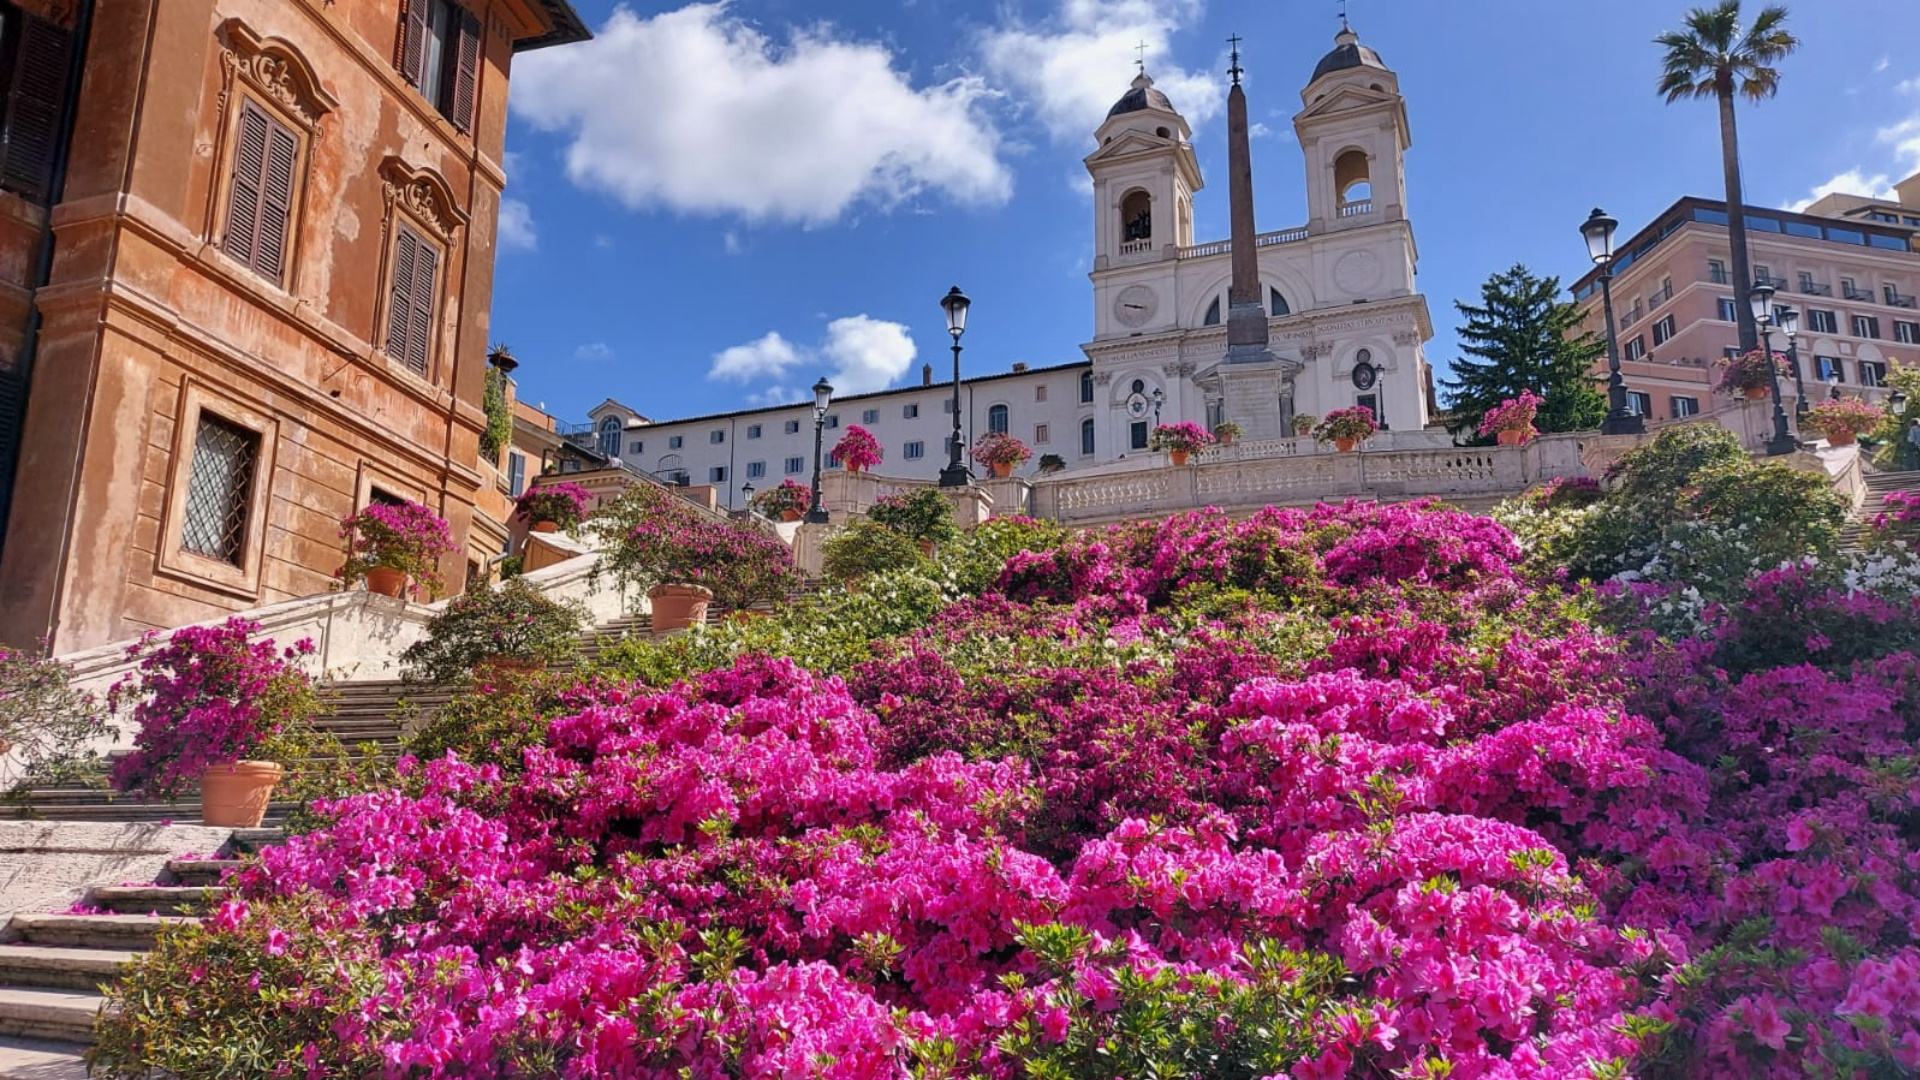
[108,617,313,798]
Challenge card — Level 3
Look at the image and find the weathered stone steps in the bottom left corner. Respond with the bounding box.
[0,828,280,1060]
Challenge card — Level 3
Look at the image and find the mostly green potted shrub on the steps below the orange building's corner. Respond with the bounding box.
[399,578,588,682]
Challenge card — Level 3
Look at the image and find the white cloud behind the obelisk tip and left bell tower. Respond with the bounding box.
[979,0,1225,146]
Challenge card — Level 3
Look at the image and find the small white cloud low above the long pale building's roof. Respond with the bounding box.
[707,315,918,405]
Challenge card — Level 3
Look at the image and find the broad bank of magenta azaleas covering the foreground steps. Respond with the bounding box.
[96,424,1920,1080]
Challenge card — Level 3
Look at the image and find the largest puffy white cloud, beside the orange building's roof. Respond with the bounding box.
[513,0,1014,225]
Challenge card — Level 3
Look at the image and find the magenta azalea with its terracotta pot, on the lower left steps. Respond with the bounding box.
[108,615,321,828]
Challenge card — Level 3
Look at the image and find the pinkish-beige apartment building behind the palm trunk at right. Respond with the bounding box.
[1572,175,1920,423]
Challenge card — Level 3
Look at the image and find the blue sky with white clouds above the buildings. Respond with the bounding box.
[492,0,1920,421]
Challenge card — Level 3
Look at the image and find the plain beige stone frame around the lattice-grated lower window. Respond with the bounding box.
[157,380,280,600]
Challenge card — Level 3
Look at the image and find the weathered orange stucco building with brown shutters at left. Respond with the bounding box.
[0,0,586,651]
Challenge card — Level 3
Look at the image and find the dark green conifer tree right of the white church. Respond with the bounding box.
[1440,263,1607,442]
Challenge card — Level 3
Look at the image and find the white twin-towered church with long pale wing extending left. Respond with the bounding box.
[589,29,1432,505]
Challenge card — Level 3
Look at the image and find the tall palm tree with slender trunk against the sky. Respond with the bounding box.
[1653,0,1799,350]
